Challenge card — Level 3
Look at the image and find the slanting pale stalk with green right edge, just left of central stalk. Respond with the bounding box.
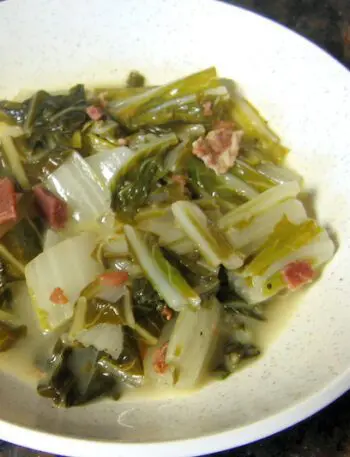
[124,225,200,311]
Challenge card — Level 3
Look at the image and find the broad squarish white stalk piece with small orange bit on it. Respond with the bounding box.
[25,232,103,332]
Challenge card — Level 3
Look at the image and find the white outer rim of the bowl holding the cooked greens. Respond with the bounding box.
[0,0,350,457]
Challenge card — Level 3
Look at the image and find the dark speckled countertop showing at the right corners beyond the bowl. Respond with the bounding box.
[211,0,350,457]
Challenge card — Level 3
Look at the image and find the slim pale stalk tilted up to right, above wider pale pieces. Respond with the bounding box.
[218,181,300,230]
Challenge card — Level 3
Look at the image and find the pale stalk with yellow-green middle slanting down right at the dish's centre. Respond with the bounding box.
[172,201,243,269]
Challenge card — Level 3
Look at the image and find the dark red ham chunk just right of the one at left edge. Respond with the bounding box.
[33,185,68,230]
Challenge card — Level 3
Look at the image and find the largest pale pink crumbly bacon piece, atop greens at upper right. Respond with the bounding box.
[192,128,243,175]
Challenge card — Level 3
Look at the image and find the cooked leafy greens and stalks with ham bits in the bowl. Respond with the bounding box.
[0,68,334,406]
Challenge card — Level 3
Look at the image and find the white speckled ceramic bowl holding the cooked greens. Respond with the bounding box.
[0,0,350,457]
